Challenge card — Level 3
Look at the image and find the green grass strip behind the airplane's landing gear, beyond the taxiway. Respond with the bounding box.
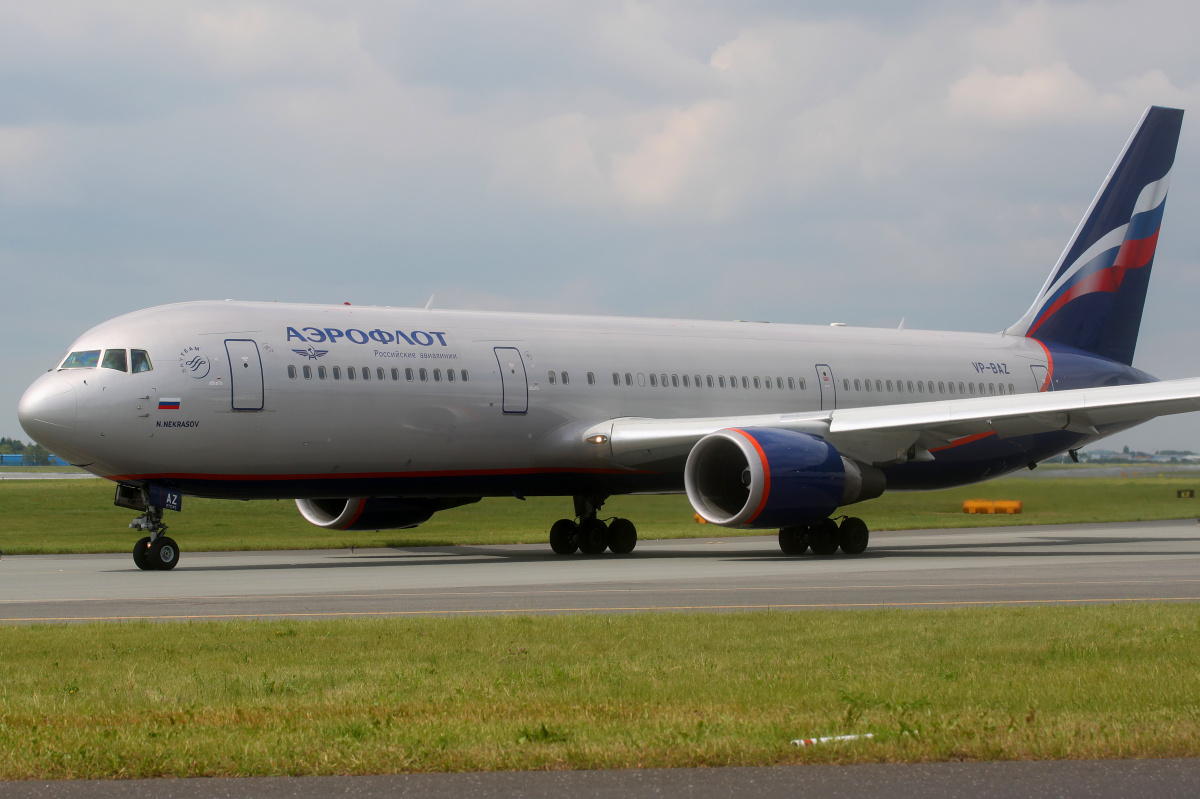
[7,476,1200,554]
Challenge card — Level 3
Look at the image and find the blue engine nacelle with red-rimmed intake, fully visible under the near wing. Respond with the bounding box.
[684,427,884,529]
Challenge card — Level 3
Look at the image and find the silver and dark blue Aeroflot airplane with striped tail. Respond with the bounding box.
[18,107,1200,570]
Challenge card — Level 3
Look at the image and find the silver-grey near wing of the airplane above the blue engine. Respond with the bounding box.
[584,378,1200,467]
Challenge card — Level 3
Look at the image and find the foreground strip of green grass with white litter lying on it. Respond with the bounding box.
[0,603,1200,780]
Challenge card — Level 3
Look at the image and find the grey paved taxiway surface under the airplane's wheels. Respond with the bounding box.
[0,519,1200,623]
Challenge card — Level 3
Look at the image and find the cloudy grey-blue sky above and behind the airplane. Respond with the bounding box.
[0,0,1200,450]
